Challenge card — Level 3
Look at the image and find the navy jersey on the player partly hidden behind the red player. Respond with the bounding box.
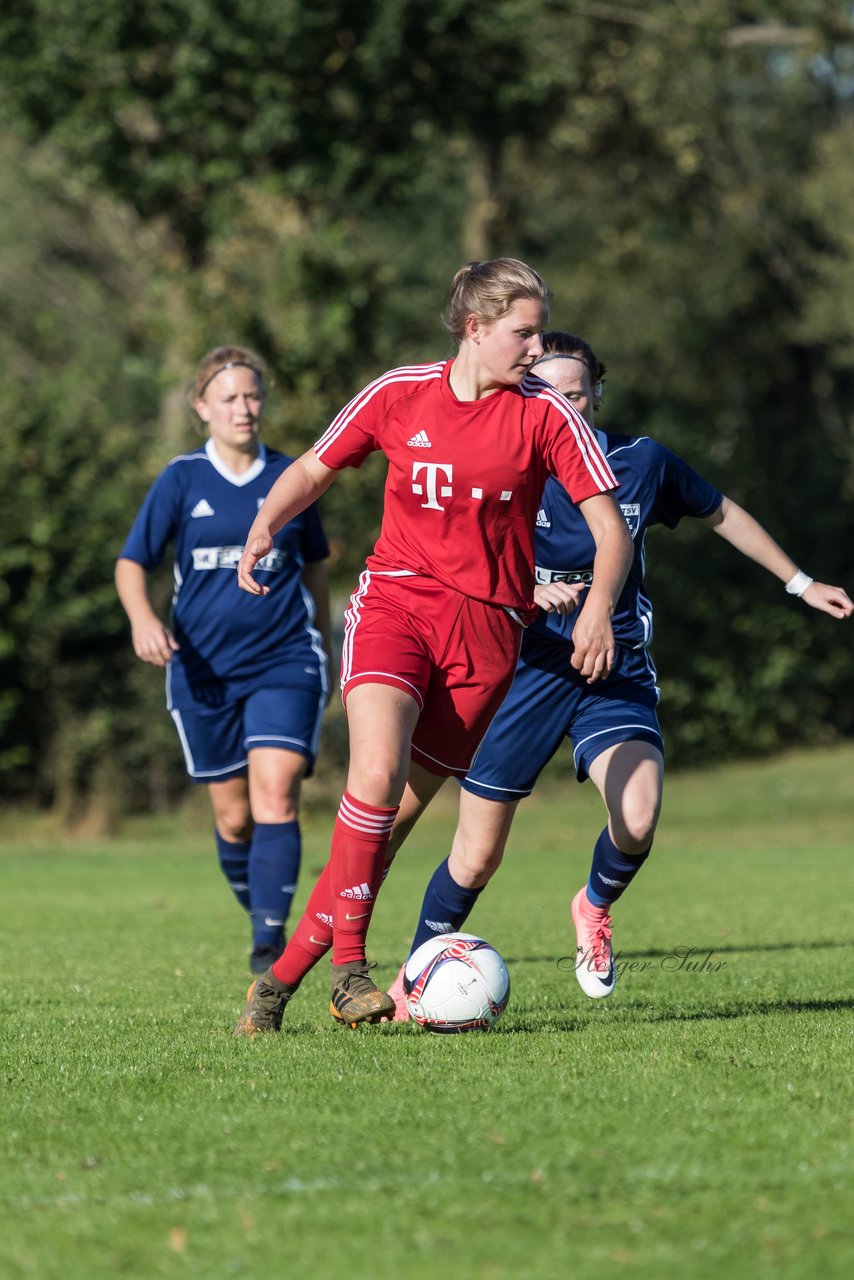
[529,431,723,649]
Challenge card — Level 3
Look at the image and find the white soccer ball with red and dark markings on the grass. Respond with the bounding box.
[403,933,510,1036]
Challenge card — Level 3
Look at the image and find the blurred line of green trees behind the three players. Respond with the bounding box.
[0,0,854,817]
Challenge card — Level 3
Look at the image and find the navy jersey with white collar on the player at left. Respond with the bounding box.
[120,440,329,709]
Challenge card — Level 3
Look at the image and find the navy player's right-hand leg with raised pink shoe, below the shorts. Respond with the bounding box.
[572,739,663,1000]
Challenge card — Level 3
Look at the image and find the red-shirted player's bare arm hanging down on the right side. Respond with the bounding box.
[571,493,635,685]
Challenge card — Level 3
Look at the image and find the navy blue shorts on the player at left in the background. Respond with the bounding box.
[172,686,326,782]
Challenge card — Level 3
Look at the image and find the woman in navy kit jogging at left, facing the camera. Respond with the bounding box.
[115,347,329,973]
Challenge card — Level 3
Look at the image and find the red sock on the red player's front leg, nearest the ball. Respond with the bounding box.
[329,791,398,964]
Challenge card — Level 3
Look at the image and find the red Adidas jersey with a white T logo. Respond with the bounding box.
[314,361,617,611]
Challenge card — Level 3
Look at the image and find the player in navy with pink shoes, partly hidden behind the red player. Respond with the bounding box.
[391,333,854,1018]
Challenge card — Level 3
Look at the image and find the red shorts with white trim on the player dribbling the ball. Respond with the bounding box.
[341,570,522,778]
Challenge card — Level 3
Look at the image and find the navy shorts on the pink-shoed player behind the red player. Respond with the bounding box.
[462,636,663,801]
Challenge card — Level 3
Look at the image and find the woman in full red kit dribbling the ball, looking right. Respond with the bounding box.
[236,259,632,1036]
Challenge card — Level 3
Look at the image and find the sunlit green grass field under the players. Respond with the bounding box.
[0,749,854,1280]
